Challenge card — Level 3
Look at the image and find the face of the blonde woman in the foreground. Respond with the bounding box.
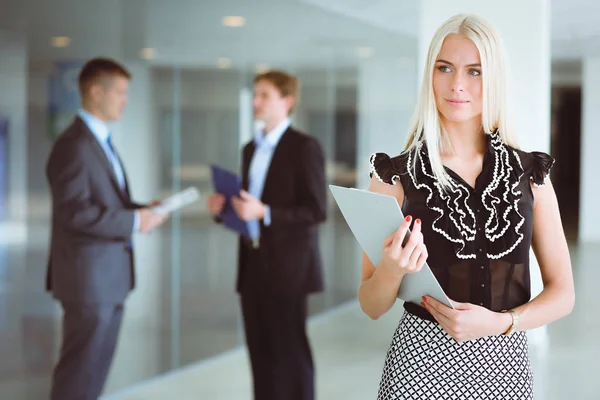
[433,35,483,123]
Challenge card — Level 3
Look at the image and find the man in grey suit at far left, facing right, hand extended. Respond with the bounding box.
[46,58,166,400]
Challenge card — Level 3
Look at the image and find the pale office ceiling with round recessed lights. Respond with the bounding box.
[0,0,600,69]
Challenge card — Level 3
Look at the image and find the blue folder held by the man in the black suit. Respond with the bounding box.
[211,165,251,239]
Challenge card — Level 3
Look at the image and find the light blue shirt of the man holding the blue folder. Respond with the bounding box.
[248,118,290,239]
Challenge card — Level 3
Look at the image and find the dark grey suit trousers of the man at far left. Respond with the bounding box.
[50,303,123,400]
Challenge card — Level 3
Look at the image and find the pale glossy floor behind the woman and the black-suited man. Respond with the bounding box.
[106,244,600,400]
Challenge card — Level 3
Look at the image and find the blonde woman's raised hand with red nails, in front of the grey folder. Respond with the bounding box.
[379,215,427,279]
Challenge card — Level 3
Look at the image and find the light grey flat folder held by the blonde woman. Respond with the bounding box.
[329,185,454,308]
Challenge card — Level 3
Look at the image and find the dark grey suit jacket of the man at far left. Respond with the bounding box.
[46,118,140,304]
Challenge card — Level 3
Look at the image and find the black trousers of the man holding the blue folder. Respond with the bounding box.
[241,251,314,400]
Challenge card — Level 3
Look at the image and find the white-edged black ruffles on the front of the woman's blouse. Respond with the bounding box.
[407,132,525,259]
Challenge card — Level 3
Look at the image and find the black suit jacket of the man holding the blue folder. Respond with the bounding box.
[237,127,327,294]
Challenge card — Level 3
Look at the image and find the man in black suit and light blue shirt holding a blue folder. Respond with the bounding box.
[208,71,327,400]
